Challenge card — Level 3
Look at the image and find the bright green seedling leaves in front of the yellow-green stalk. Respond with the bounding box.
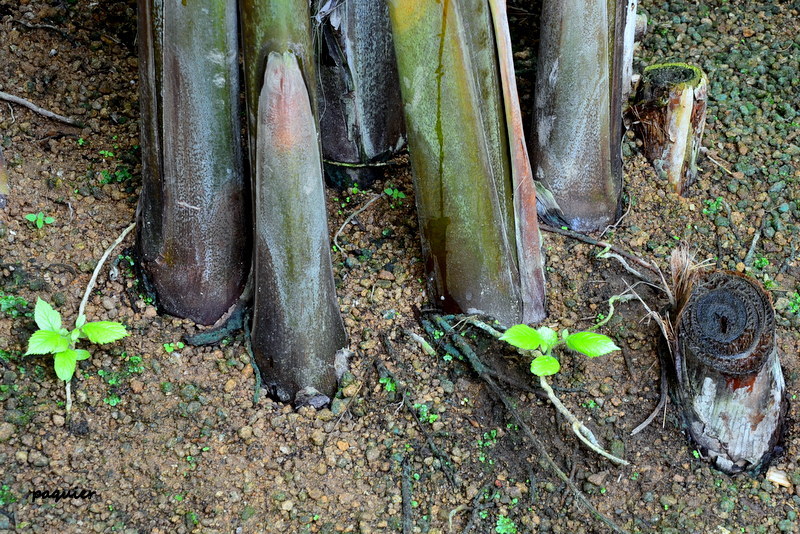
[500,324,620,376]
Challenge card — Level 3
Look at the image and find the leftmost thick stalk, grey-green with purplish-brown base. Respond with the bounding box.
[137,0,249,324]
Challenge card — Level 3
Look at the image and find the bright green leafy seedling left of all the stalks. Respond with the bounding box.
[25,298,128,382]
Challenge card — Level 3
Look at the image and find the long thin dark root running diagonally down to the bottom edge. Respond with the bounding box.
[432,316,628,534]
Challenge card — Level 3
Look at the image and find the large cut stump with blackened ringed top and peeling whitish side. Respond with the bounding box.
[670,270,786,473]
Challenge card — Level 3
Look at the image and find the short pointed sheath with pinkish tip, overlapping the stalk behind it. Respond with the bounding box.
[252,52,347,401]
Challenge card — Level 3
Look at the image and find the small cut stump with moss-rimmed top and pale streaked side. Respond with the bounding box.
[632,63,708,195]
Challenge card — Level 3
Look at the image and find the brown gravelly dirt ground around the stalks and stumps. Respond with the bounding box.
[0,0,800,534]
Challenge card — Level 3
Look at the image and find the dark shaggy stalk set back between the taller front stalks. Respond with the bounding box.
[314,0,405,186]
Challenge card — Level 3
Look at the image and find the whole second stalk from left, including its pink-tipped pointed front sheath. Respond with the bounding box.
[240,0,347,405]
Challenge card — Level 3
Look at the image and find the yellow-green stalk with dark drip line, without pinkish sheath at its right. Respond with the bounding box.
[389,0,523,325]
